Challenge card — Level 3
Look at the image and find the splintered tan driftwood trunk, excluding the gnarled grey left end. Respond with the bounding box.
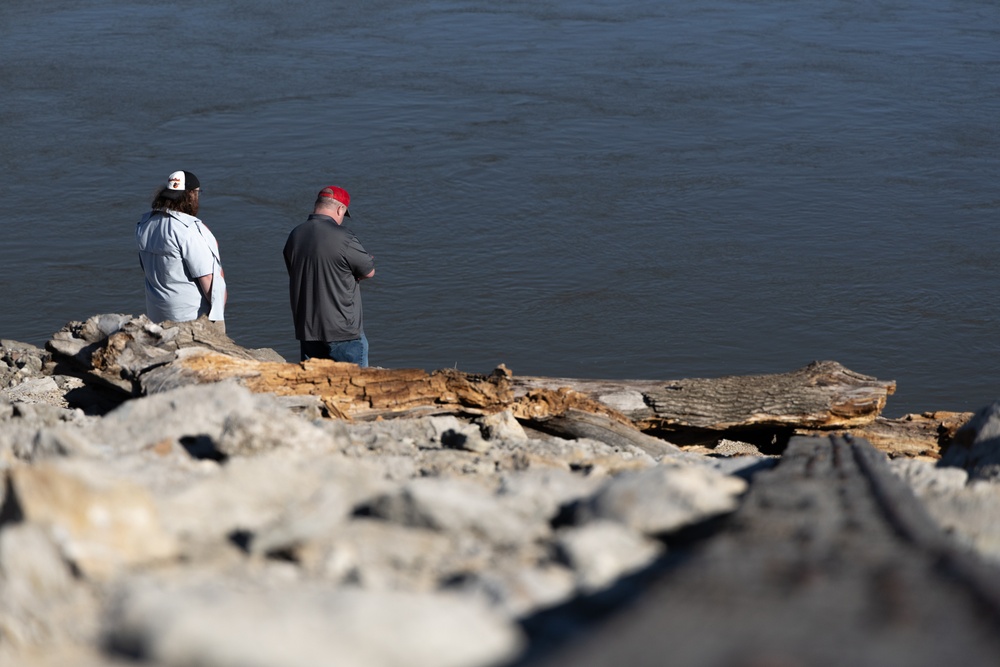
[137,352,895,431]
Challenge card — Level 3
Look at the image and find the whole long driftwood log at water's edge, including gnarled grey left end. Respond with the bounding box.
[49,315,895,437]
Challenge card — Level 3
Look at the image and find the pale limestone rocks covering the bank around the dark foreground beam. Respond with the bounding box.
[0,316,1000,667]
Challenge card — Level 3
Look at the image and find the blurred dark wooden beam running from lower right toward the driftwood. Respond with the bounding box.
[529,438,1000,667]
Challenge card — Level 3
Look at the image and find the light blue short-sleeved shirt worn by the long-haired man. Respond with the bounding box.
[135,211,226,322]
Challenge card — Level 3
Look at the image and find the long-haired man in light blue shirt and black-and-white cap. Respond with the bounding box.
[135,171,228,330]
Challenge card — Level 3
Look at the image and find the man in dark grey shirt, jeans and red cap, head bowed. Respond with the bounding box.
[284,185,375,367]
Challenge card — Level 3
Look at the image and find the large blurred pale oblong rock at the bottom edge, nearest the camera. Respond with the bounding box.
[107,582,523,667]
